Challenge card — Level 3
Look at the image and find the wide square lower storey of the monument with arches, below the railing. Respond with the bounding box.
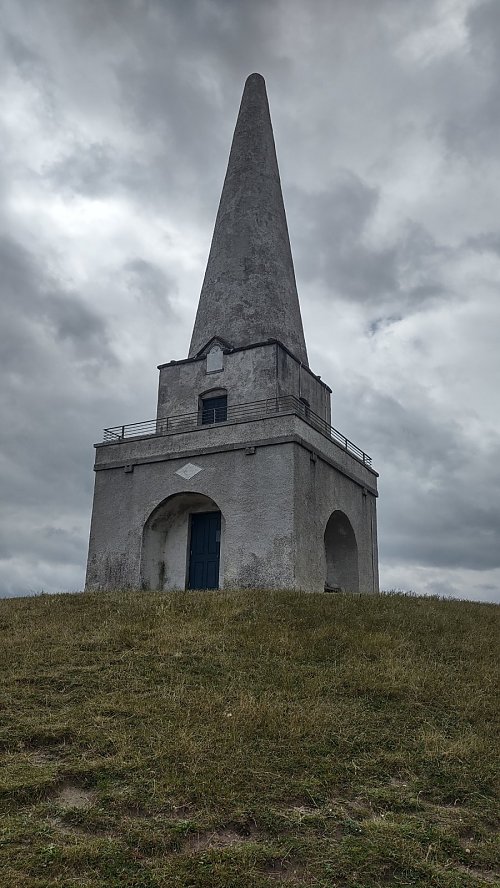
[86,414,378,592]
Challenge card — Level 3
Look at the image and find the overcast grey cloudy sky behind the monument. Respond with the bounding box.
[0,0,500,601]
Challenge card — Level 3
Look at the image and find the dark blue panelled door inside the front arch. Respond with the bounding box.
[189,512,220,589]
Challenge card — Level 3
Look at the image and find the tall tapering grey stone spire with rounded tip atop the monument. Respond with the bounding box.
[189,74,308,366]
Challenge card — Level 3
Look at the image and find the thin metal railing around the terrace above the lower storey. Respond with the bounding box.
[103,395,372,466]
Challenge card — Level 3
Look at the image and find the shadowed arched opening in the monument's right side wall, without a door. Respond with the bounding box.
[325,510,359,592]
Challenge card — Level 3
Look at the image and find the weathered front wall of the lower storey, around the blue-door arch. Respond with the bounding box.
[87,444,294,588]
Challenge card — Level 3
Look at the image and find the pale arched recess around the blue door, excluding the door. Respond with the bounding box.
[141,491,225,589]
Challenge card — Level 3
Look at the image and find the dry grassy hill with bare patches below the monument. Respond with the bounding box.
[0,591,500,888]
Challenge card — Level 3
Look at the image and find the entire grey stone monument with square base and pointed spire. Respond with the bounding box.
[86,74,378,592]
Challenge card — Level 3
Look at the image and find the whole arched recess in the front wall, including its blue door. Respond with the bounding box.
[141,493,224,589]
